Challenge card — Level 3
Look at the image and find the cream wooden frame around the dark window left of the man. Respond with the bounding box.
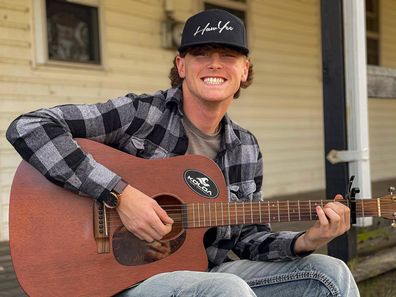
[32,0,105,70]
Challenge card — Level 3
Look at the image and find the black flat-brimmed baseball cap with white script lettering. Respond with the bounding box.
[178,9,249,55]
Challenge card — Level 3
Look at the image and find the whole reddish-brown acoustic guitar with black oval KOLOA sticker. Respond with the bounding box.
[9,139,396,296]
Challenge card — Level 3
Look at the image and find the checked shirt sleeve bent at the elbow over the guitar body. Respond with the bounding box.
[6,97,134,200]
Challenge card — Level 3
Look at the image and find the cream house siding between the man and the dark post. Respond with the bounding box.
[231,0,324,197]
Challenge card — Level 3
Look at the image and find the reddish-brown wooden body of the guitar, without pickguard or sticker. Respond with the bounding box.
[9,140,227,296]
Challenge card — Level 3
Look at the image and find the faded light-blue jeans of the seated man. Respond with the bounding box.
[120,254,359,297]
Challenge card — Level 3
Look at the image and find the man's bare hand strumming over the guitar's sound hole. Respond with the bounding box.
[117,185,173,242]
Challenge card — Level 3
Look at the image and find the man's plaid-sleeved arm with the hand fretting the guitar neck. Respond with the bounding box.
[234,147,350,261]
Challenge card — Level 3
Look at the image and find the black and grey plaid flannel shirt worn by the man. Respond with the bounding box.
[7,88,301,266]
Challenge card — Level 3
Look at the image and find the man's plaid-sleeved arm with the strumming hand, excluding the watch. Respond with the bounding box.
[7,97,173,242]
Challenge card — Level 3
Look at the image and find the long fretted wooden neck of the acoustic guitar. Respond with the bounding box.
[183,199,381,228]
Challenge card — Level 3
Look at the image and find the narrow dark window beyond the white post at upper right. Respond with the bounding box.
[366,0,380,65]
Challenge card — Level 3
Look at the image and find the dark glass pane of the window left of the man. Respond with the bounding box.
[46,0,100,64]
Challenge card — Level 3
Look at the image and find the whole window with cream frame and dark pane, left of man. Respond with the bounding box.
[34,0,102,66]
